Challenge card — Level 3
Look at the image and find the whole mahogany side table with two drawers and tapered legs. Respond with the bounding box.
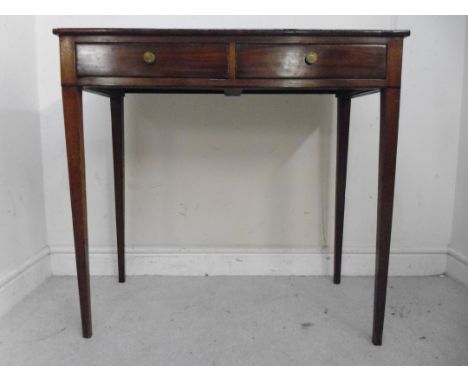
[53,28,410,345]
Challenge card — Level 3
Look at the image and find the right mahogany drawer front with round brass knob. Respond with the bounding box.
[237,44,387,79]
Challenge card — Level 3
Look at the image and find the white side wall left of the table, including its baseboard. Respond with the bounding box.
[0,17,50,314]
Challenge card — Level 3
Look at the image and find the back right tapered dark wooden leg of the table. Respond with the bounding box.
[333,96,351,284]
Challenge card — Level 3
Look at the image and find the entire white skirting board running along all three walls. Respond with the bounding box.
[0,247,462,316]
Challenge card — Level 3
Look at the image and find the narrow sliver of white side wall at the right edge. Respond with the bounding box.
[448,19,468,284]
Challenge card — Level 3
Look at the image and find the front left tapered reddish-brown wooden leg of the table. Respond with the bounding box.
[62,86,92,338]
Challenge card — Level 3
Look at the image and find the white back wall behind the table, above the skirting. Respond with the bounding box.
[31,16,466,272]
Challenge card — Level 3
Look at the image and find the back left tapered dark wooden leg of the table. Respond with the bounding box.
[111,95,125,283]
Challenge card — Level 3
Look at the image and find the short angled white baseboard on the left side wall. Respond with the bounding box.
[0,247,52,316]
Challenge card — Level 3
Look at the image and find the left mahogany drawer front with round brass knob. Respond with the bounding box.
[76,43,227,78]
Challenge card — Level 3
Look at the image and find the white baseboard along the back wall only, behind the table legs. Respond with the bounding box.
[51,247,447,276]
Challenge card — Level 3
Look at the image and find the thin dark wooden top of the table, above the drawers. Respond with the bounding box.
[53,28,410,37]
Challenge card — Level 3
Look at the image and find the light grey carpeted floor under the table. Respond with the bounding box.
[0,276,468,365]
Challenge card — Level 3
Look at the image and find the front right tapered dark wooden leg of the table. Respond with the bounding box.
[372,88,400,345]
